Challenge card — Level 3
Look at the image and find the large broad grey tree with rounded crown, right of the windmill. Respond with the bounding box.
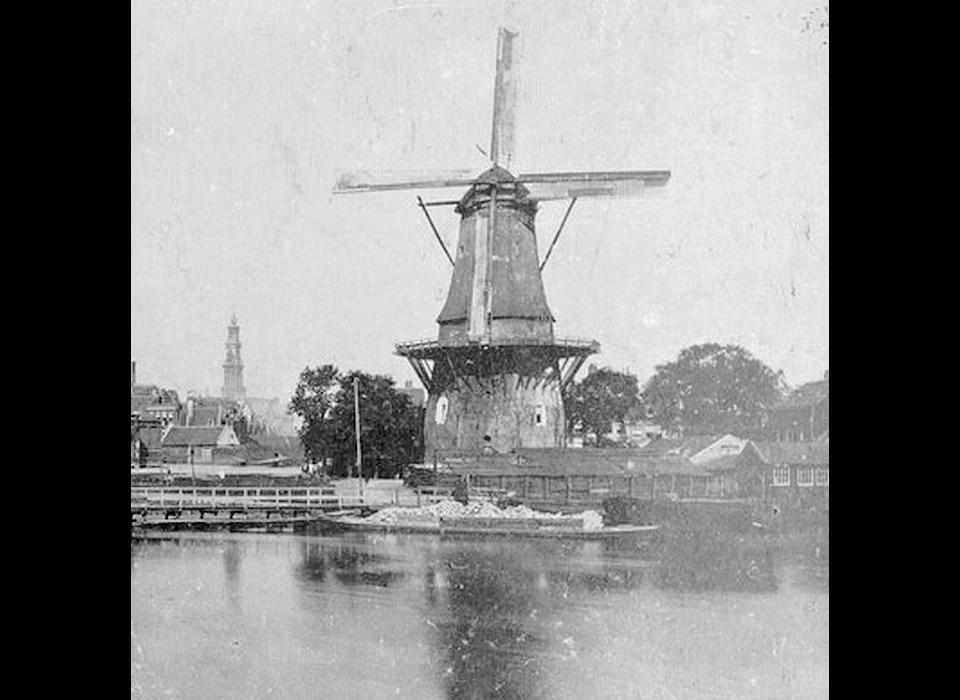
[643,343,782,436]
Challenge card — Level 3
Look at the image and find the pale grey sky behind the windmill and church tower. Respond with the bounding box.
[130,0,830,399]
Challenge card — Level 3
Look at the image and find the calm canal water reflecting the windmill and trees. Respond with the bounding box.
[130,528,830,700]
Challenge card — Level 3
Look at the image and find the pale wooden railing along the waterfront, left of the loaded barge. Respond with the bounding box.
[130,486,364,508]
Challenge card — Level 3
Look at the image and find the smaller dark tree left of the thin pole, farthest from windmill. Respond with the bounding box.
[287,365,342,464]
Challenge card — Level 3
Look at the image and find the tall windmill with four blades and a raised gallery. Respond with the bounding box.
[334,28,670,460]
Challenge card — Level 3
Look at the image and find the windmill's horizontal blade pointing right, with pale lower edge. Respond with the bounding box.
[517,170,670,201]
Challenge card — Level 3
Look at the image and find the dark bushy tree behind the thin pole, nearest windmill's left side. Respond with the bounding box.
[330,372,423,477]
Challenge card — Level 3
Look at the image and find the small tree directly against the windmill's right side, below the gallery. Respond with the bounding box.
[564,367,640,439]
